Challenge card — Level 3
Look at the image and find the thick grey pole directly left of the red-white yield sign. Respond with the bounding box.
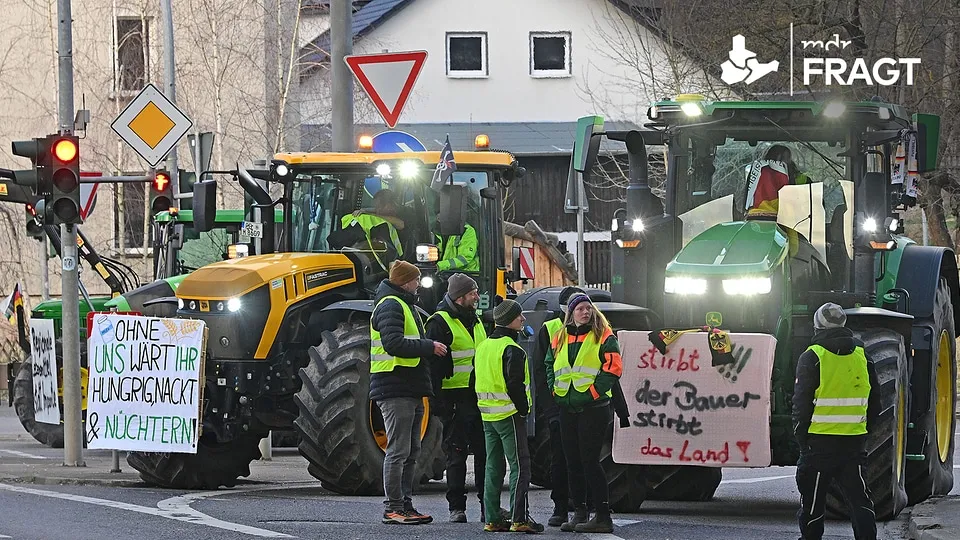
[330,0,356,152]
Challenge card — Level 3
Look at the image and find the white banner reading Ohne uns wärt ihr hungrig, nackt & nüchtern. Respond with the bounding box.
[86,314,206,454]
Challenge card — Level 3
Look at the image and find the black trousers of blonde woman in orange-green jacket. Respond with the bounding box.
[560,400,610,509]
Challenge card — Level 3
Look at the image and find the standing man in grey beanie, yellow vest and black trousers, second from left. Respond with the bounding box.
[426,274,487,523]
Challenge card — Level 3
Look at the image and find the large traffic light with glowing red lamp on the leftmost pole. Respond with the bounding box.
[48,135,82,225]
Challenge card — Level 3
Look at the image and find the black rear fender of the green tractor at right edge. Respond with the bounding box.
[892,244,960,420]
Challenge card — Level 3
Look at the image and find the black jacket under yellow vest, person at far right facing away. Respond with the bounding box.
[793,328,880,452]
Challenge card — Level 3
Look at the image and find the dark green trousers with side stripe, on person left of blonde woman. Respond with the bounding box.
[483,414,530,523]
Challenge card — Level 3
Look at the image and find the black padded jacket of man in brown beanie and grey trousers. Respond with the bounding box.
[370,279,433,401]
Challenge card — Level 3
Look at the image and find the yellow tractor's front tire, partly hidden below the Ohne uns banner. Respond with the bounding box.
[127,433,266,489]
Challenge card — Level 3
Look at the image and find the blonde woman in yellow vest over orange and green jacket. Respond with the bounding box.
[544,293,623,533]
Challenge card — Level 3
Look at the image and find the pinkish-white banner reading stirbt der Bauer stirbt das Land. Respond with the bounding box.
[613,331,777,467]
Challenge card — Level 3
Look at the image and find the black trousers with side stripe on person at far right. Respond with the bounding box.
[797,453,877,540]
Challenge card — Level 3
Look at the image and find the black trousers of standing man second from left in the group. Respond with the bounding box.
[439,391,487,511]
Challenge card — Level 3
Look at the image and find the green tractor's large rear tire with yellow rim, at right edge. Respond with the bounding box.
[906,279,957,505]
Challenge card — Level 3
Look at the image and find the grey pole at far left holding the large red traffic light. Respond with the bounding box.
[57,0,85,467]
